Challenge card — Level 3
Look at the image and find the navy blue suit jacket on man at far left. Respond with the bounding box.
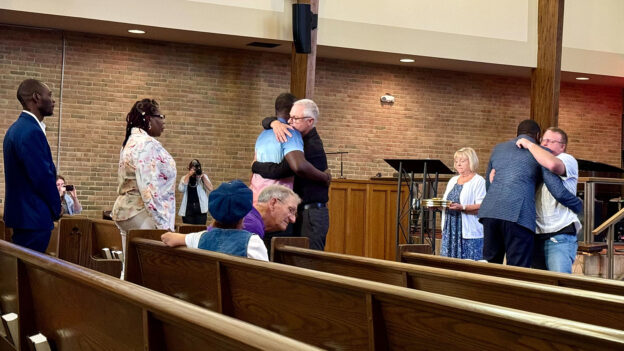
[3,112,61,230]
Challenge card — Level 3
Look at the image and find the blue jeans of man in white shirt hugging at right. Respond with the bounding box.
[531,234,578,273]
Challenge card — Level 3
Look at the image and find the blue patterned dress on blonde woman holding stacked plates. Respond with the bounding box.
[440,184,483,261]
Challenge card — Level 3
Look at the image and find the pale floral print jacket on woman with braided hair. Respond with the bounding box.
[111,128,176,230]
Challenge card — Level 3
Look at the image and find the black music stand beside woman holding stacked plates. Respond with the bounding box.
[384,159,454,261]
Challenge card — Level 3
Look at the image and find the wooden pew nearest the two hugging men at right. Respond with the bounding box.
[401,245,624,296]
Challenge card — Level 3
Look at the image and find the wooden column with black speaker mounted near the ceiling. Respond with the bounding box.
[290,0,319,99]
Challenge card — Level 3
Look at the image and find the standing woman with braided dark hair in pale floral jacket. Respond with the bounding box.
[111,99,176,277]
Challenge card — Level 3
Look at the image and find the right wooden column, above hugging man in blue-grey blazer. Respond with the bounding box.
[531,0,565,130]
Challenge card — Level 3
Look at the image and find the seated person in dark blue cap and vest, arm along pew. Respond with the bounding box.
[161,180,269,261]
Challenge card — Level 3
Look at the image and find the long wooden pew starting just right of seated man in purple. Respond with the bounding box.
[272,238,624,330]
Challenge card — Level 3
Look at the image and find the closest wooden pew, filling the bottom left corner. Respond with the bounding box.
[0,241,317,351]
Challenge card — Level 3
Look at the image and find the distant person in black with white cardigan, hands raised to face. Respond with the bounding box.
[178,160,213,224]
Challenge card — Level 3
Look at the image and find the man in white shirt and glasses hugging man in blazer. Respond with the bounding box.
[517,127,581,273]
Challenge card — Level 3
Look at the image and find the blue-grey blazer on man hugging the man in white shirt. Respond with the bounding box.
[479,135,583,231]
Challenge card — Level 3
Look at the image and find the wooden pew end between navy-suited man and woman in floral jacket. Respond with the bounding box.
[53,217,121,277]
